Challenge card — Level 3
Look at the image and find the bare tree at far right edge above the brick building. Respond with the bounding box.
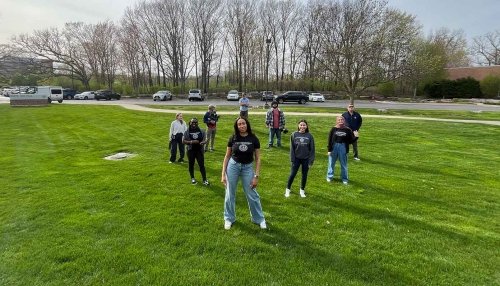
[471,30,500,66]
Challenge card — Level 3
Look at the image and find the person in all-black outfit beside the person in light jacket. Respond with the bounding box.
[183,118,210,186]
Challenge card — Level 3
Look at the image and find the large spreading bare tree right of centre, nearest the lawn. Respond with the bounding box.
[320,0,418,102]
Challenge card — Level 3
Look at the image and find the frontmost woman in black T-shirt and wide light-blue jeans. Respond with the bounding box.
[221,117,267,229]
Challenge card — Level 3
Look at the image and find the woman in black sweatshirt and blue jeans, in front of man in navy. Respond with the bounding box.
[326,116,355,185]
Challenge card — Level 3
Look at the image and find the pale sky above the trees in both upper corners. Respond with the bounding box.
[0,0,500,44]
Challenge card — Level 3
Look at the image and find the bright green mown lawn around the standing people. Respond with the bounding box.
[0,104,500,285]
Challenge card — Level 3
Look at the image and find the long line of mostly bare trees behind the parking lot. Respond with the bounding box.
[0,0,500,100]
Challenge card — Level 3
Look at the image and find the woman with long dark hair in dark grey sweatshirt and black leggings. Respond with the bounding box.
[285,119,316,198]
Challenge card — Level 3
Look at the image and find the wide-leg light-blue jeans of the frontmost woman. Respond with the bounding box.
[224,158,264,224]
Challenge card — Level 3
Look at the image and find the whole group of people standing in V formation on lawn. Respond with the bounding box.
[169,100,362,229]
